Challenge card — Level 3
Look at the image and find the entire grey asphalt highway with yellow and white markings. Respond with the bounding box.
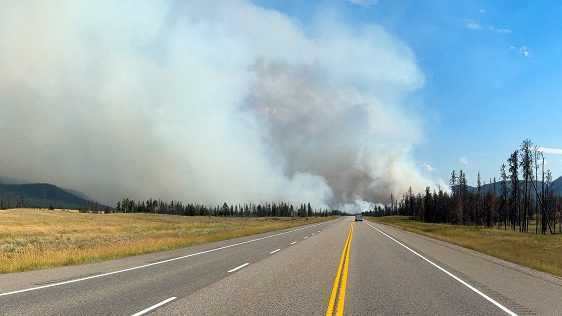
[0,218,562,315]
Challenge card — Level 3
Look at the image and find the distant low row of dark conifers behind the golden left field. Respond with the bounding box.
[115,198,341,217]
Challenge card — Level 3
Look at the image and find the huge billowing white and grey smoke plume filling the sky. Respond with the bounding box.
[0,0,429,206]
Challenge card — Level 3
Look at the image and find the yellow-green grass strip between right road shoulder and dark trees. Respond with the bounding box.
[368,216,562,276]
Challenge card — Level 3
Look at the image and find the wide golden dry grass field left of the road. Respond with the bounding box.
[0,209,327,273]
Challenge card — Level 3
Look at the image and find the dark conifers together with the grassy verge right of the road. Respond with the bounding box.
[364,139,562,276]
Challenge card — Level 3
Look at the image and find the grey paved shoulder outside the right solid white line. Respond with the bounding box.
[371,223,562,315]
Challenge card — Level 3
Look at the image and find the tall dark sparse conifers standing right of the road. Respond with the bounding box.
[366,139,562,234]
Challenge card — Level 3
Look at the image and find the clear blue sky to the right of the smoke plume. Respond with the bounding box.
[256,0,562,182]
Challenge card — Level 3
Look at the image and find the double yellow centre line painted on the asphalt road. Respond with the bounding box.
[326,223,353,316]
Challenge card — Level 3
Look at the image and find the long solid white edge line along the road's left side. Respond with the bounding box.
[0,223,325,297]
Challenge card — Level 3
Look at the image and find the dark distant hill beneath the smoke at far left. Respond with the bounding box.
[0,183,108,209]
